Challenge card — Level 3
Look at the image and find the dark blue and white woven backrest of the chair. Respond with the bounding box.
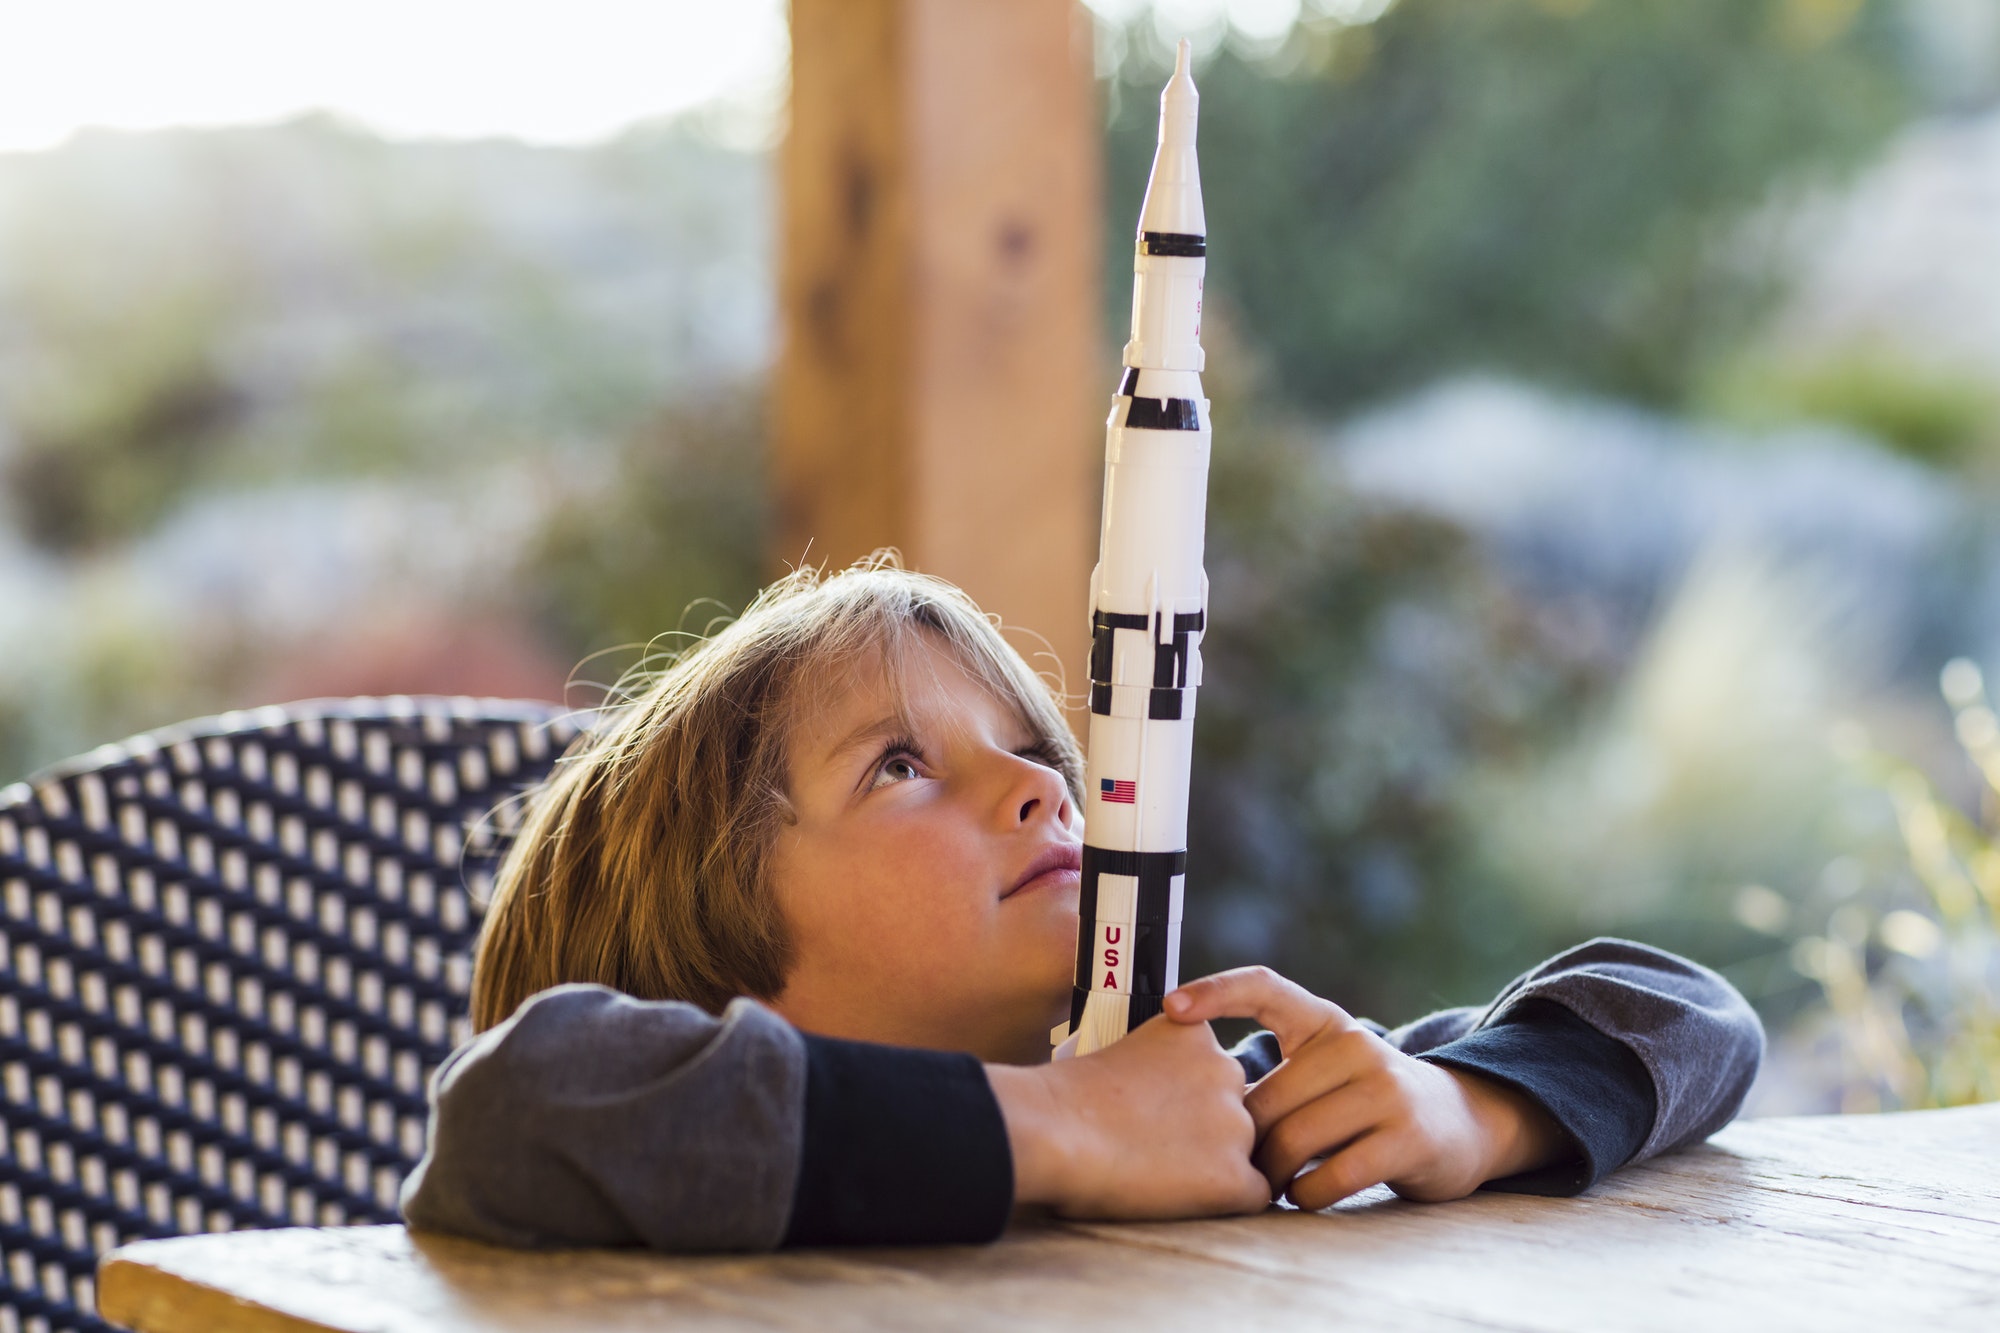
[0,699,578,1333]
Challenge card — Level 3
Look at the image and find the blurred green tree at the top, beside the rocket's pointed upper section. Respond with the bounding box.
[1106,0,1910,408]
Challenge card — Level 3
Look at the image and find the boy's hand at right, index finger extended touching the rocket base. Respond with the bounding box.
[1168,967,1564,1209]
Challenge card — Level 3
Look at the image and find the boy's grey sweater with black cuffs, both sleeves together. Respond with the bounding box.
[402,939,1764,1251]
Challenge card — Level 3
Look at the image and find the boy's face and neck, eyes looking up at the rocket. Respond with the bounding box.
[772,634,1084,1061]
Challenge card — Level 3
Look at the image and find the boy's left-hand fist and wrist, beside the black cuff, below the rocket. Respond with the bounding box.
[986,1019,1270,1219]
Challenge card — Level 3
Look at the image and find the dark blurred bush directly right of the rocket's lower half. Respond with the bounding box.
[1182,338,1608,1021]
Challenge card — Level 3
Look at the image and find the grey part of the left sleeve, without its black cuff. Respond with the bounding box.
[402,985,806,1251]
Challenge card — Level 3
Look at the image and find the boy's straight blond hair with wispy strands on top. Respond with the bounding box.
[472,552,1082,1031]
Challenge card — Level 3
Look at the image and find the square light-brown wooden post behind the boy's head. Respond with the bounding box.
[772,0,1116,712]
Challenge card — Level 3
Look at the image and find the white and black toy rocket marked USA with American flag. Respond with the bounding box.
[1058,42,1208,1055]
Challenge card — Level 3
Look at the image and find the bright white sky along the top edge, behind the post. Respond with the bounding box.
[0,0,1384,152]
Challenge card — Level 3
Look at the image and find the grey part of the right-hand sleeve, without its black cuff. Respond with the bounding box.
[1388,939,1764,1161]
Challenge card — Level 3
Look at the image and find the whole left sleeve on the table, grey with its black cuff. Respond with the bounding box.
[402,987,1012,1251]
